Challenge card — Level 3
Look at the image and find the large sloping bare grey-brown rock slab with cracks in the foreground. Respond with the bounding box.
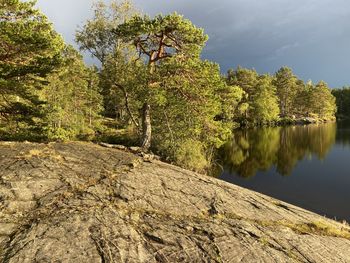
[0,142,350,263]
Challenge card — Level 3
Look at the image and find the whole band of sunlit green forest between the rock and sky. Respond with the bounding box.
[0,0,340,172]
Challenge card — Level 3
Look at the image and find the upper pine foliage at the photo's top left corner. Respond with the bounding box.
[0,0,63,77]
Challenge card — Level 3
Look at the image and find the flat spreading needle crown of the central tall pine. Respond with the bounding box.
[114,13,208,62]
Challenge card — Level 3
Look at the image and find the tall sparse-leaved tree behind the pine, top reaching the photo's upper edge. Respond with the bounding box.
[76,0,137,120]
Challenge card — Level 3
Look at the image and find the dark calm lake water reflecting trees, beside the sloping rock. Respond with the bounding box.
[220,122,350,222]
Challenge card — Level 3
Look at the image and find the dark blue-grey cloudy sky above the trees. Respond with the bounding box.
[37,0,350,87]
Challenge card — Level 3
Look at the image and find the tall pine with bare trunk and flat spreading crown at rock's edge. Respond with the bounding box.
[114,13,207,151]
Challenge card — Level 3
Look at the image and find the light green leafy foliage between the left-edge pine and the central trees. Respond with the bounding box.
[41,46,102,140]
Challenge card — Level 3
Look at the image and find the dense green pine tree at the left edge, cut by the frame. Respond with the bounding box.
[0,0,63,139]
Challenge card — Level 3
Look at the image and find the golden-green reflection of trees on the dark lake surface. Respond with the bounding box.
[221,123,338,177]
